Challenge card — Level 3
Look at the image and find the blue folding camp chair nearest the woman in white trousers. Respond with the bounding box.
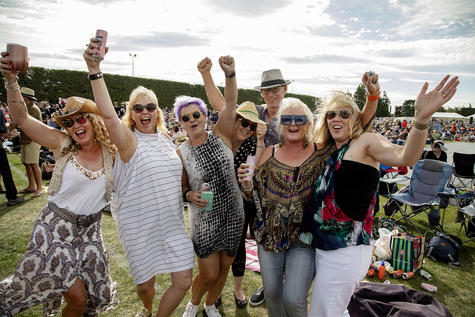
[390,160,452,235]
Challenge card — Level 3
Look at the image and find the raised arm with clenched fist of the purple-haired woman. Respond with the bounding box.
[213,56,237,147]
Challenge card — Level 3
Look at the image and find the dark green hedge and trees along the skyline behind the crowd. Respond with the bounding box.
[5,67,475,117]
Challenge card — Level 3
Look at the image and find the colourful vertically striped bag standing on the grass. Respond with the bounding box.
[391,232,425,272]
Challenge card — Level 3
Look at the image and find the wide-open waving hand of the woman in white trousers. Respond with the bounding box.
[414,75,460,120]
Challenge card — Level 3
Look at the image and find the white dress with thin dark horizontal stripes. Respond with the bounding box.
[111,130,194,284]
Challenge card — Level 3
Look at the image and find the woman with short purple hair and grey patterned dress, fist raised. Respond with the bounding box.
[178,56,244,317]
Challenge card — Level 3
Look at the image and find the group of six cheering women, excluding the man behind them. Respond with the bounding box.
[0,32,459,316]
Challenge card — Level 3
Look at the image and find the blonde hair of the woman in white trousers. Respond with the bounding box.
[314,91,363,145]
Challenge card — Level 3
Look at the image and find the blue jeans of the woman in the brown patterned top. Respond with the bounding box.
[258,244,315,317]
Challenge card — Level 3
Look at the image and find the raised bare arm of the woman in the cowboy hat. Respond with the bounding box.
[0,52,66,150]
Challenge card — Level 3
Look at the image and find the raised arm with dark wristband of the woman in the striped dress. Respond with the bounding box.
[83,38,137,162]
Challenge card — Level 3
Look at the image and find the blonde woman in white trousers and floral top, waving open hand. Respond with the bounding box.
[300,75,459,317]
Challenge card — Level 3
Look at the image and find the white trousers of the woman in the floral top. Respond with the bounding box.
[309,245,373,317]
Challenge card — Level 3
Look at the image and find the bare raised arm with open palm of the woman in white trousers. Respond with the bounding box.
[367,75,459,166]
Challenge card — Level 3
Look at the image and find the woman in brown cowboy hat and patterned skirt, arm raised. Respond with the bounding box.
[0,52,118,316]
